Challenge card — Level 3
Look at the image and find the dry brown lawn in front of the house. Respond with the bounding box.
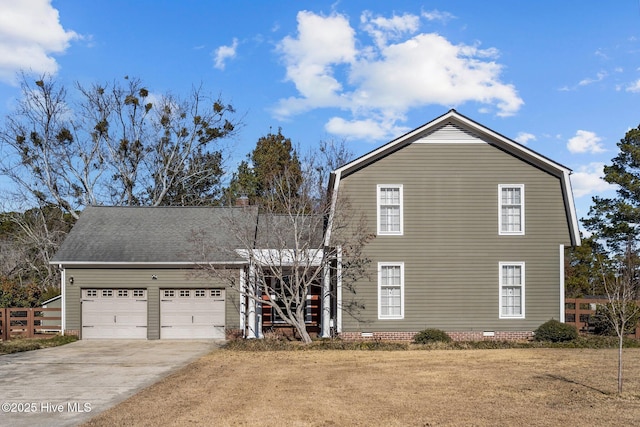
[86,349,640,426]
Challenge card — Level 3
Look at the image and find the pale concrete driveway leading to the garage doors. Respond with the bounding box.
[0,340,221,427]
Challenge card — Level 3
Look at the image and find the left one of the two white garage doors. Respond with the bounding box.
[82,289,147,339]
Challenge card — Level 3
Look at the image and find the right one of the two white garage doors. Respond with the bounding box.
[160,289,225,339]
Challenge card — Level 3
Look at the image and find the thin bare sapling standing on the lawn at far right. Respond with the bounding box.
[598,244,640,393]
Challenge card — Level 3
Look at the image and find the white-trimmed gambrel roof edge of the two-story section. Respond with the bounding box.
[326,110,580,245]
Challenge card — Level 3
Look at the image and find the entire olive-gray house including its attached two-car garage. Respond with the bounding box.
[52,110,580,339]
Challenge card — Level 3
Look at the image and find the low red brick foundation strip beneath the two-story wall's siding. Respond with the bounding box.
[339,331,533,341]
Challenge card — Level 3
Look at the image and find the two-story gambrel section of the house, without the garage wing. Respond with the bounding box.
[327,110,580,339]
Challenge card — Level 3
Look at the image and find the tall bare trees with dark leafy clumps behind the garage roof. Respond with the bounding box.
[0,75,239,219]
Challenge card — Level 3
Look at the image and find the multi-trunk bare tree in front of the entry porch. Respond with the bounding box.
[198,145,372,343]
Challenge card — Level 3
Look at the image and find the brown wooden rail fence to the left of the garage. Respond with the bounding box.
[0,307,62,341]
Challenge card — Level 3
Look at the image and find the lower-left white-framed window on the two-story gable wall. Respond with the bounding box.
[378,262,404,319]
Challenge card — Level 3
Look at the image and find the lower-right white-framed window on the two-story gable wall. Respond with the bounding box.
[499,262,524,319]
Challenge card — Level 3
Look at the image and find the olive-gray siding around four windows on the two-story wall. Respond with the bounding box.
[338,142,570,332]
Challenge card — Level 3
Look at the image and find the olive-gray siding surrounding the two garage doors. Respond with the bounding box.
[65,268,240,339]
